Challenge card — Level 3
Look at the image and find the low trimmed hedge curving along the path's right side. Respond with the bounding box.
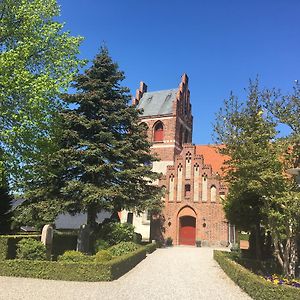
[214,250,300,300]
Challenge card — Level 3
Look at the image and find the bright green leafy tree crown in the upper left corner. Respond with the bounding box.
[0,0,82,184]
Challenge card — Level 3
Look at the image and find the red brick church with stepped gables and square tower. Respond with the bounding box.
[121,74,234,246]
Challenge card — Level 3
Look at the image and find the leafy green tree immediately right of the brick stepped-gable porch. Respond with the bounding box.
[214,81,284,231]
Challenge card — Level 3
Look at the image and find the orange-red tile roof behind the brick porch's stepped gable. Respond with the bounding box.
[196,145,229,175]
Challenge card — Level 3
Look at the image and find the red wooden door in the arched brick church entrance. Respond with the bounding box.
[179,217,196,246]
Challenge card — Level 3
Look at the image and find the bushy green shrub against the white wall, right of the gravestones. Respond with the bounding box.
[100,222,134,245]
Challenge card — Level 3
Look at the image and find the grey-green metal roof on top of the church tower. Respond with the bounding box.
[137,89,178,116]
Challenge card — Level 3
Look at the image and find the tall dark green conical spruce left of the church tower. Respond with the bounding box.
[33,47,161,227]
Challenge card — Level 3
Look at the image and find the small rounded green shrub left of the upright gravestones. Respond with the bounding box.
[17,238,46,260]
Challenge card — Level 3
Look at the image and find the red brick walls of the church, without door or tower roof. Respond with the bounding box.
[133,74,228,246]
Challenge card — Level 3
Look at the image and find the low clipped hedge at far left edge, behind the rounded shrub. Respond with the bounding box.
[0,234,41,261]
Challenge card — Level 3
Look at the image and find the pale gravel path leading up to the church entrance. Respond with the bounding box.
[0,247,251,300]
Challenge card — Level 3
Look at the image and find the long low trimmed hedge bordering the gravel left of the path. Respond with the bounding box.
[0,247,146,281]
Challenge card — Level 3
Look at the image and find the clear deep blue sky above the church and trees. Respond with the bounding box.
[58,0,300,144]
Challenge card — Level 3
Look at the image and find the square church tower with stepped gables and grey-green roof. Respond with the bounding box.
[133,74,193,174]
